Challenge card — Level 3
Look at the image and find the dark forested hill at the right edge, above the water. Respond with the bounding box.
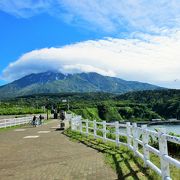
[115,89,180,119]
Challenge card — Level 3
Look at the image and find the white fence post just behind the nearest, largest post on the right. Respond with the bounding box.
[141,125,149,167]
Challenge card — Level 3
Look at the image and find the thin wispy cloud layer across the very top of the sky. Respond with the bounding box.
[0,0,180,33]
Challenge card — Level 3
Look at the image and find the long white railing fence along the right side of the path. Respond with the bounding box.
[70,116,180,180]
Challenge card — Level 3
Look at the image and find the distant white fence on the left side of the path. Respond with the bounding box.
[0,117,32,128]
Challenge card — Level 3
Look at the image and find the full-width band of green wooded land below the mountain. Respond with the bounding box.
[0,90,180,121]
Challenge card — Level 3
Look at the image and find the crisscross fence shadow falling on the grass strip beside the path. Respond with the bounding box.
[63,133,154,180]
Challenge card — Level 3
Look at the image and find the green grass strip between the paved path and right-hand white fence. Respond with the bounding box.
[64,129,180,180]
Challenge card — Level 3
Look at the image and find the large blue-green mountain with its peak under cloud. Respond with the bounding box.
[0,71,160,99]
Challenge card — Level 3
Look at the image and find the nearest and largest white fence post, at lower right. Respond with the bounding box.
[158,128,170,180]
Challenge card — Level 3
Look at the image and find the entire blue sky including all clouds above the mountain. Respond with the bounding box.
[0,0,180,89]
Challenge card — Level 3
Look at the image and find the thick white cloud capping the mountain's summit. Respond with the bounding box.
[3,31,180,88]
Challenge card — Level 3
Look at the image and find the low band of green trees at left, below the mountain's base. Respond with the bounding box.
[0,93,114,115]
